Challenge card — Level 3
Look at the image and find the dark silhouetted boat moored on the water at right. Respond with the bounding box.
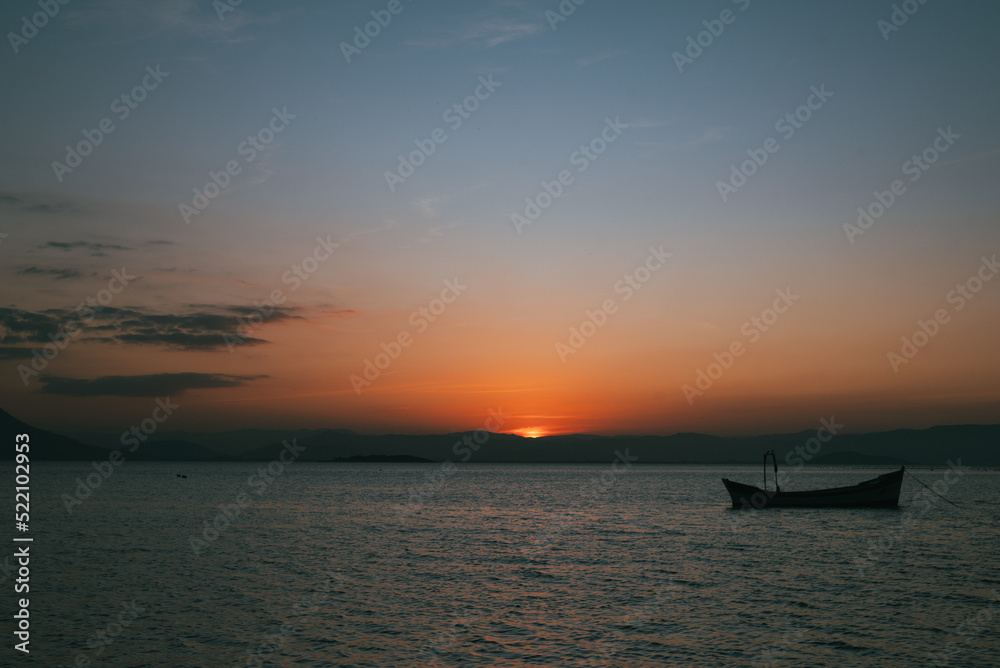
[722,450,906,508]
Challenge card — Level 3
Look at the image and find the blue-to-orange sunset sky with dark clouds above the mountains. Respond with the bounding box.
[0,0,1000,435]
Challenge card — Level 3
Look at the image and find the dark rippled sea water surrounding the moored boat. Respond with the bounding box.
[7,456,1000,667]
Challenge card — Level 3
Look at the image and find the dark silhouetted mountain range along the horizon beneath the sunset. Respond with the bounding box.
[0,409,1000,467]
